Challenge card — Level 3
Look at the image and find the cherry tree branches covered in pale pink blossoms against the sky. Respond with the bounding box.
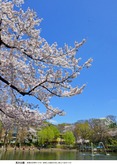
[0,0,92,127]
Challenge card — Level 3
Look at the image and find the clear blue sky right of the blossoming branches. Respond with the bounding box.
[23,0,117,123]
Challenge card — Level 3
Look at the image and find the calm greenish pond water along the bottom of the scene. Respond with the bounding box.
[0,151,117,160]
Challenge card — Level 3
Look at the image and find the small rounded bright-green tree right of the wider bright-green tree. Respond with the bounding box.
[63,131,75,145]
